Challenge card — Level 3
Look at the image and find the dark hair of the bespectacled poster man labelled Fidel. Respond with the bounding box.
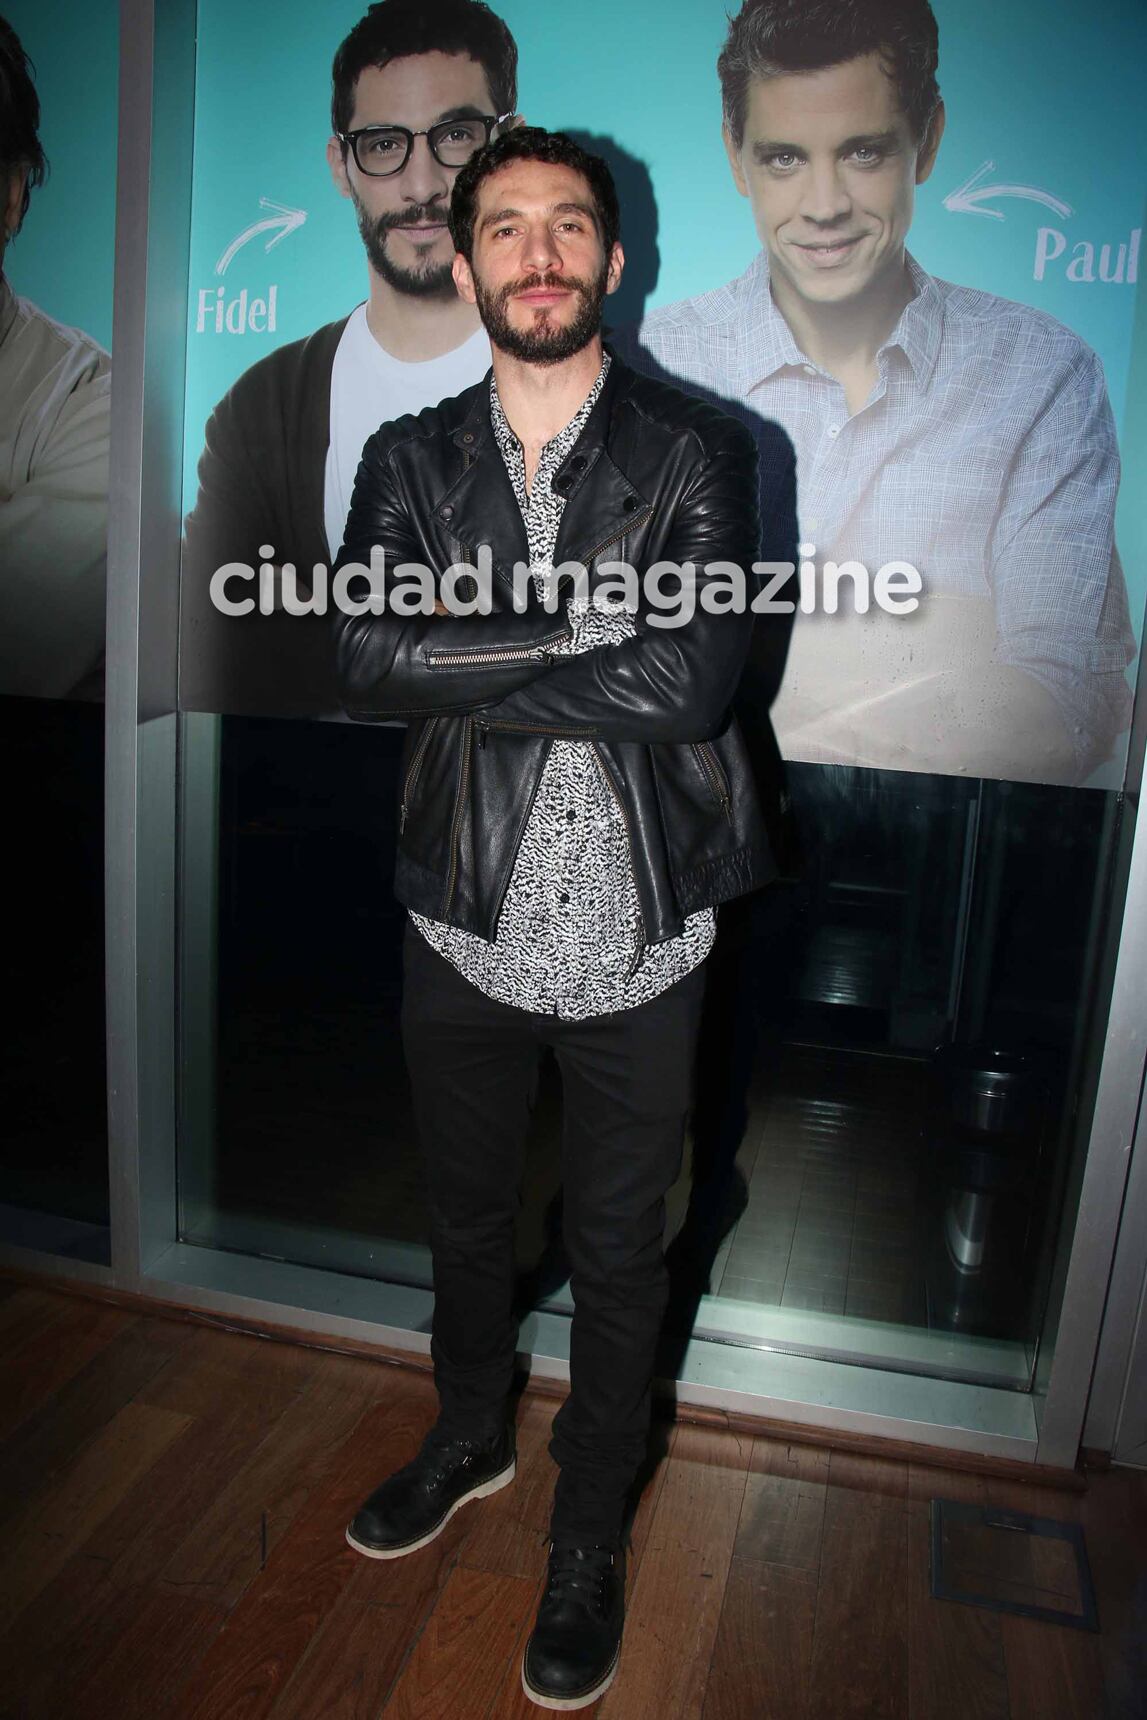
[330,0,518,131]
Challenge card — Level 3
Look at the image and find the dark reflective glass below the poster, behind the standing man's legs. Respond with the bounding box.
[182,717,1119,1386]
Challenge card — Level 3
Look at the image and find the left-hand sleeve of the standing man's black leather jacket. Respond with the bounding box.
[334,436,584,719]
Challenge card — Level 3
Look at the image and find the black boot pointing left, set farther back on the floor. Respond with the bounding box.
[346,1426,516,1558]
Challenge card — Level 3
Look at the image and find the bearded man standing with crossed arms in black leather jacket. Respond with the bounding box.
[335,129,793,1708]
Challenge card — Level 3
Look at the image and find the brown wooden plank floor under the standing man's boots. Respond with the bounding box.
[0,1281,1147,1720]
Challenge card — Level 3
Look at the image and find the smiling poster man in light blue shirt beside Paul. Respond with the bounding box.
[624,0,1135,783]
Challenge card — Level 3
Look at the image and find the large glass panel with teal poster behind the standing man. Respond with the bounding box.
[172,0,1147,1391]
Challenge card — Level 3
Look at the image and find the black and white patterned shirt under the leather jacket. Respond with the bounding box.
[411,353,715,1022]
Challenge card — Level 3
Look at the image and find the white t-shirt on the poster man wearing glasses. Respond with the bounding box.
[323,303,490,561]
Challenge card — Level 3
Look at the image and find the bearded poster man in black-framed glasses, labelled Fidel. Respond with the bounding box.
[181,0,518,716]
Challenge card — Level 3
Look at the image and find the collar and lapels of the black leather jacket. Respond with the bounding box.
[435,349,648,583]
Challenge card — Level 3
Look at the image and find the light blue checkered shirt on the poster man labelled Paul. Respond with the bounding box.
[614,251,1135,777]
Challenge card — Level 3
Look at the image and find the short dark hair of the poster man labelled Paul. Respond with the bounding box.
[717,0,941,150]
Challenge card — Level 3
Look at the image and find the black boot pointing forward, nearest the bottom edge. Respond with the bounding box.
[521,1543,626,1710]
